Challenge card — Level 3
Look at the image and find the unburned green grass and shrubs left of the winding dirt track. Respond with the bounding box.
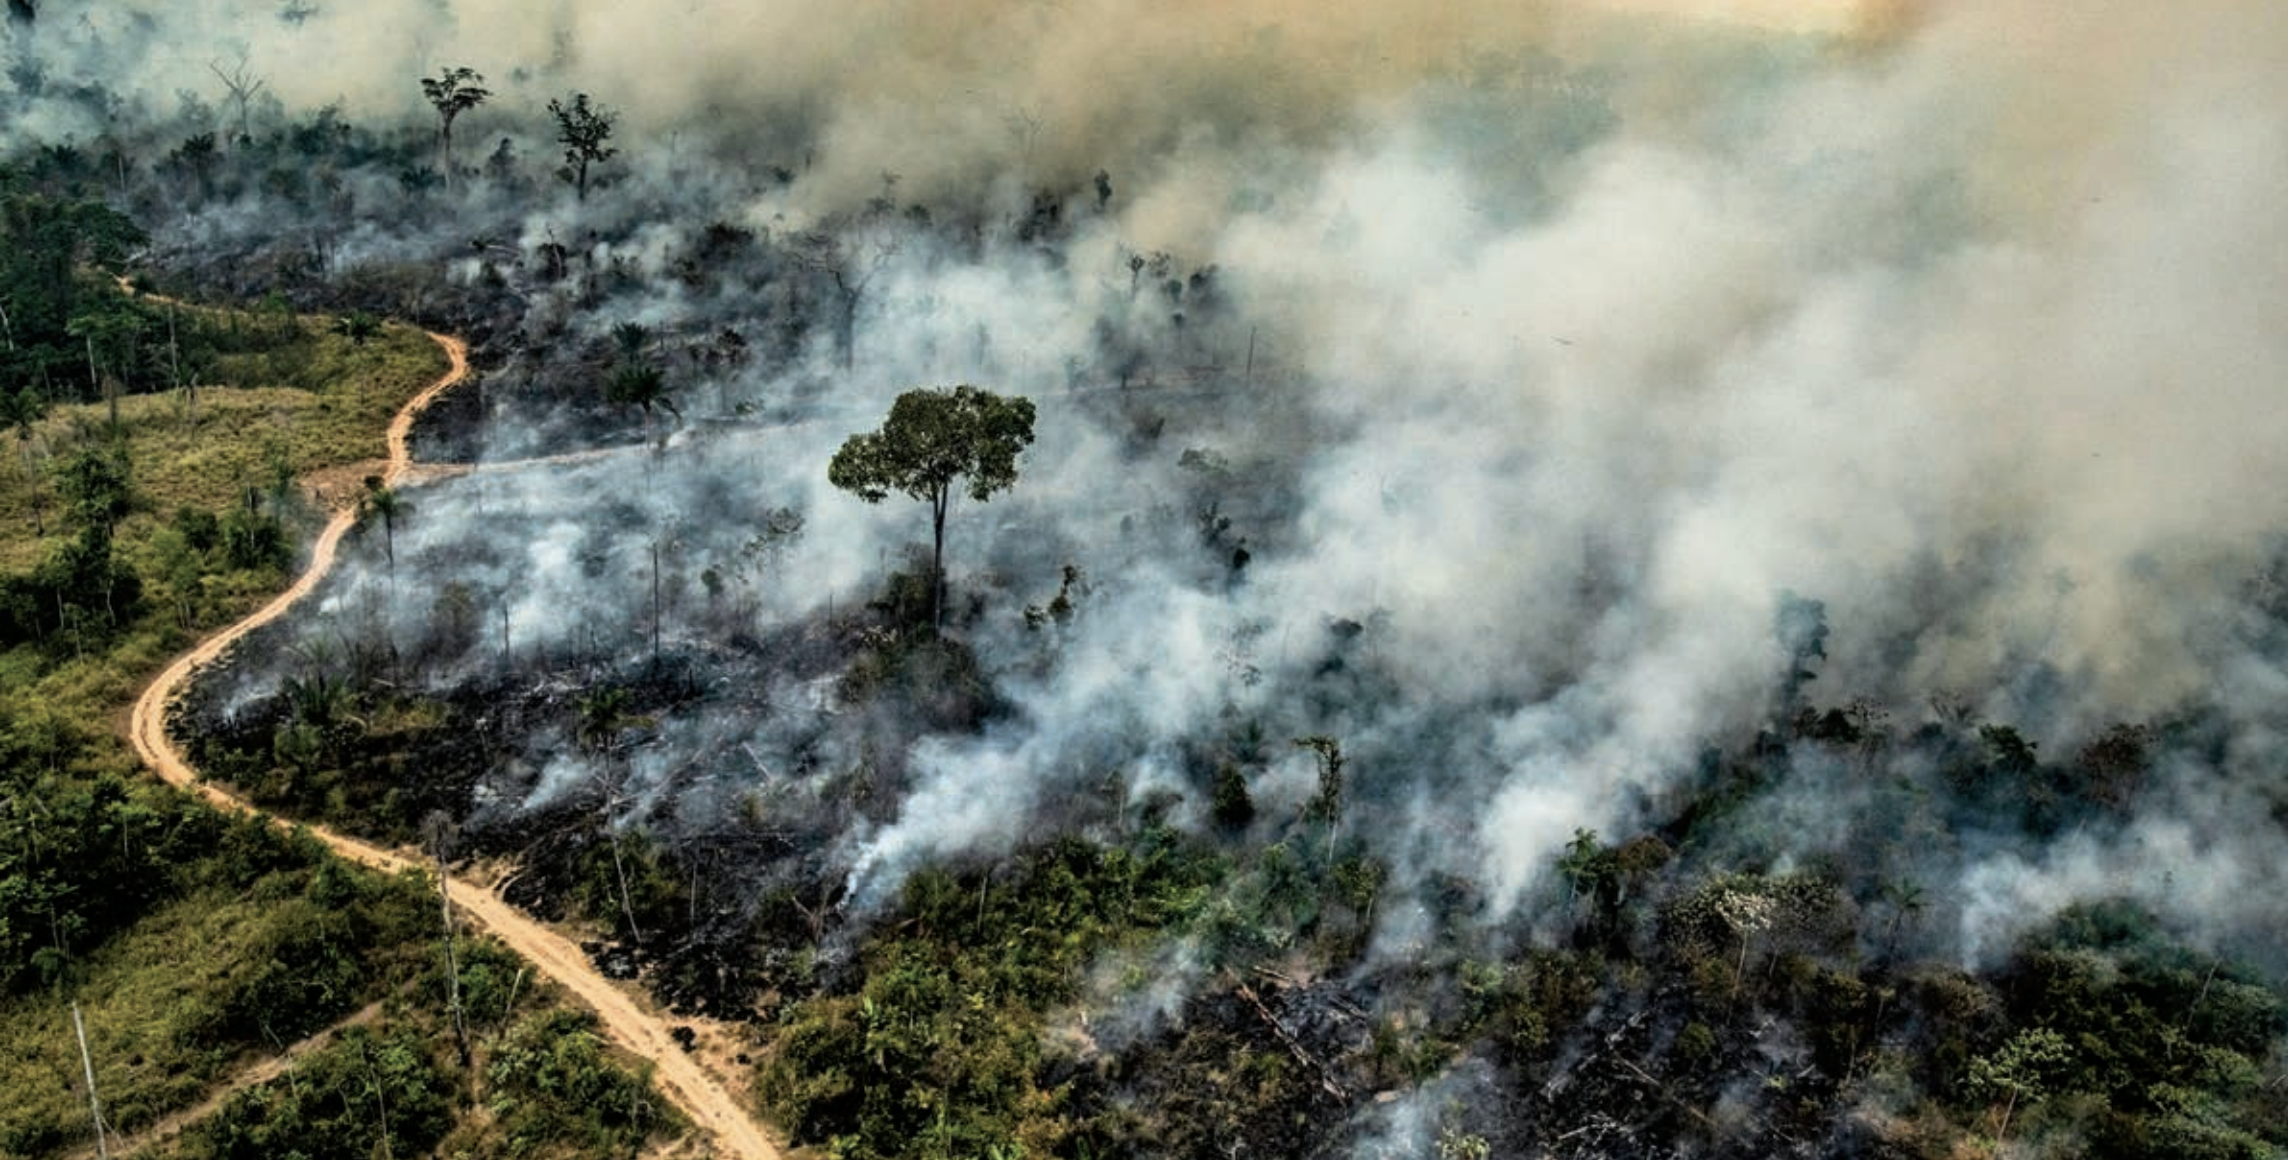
[0,219,673,1158]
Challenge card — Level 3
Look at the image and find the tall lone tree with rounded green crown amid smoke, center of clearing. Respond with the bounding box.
[826,387,1032,629]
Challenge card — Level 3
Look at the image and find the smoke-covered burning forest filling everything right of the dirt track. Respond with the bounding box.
[0,0,2288,1160]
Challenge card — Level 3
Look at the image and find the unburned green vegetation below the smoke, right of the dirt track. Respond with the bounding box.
[736,700,2288,1160]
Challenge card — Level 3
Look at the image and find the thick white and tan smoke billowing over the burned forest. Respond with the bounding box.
[26,0,2288,997]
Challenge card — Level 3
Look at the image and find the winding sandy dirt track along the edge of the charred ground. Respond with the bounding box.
[128,322,778,1160]
